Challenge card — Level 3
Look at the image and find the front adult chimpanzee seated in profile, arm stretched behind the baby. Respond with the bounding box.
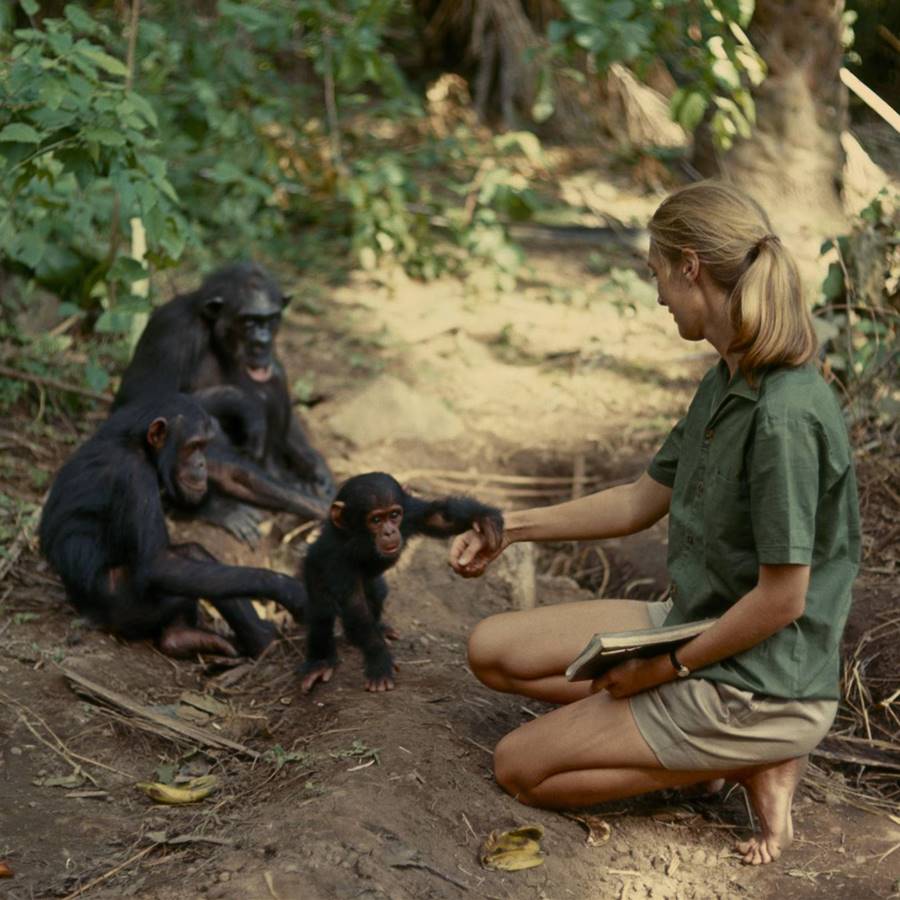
[40,394,306,656]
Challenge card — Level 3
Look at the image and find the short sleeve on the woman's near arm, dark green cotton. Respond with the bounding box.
[748,414,828,565]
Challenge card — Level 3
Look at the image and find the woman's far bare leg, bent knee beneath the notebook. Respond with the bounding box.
[469,600,650,703]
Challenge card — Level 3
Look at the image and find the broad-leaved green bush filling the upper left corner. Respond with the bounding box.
[0,0,188,330]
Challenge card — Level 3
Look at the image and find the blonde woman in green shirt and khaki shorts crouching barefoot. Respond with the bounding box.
[451,182,859,865]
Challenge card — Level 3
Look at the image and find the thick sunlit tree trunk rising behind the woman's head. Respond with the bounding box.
[695,0,847,233]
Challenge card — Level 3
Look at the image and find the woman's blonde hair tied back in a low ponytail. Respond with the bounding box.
[649,180,817,381]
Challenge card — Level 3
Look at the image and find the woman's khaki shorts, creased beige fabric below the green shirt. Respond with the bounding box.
[630,602,837,771]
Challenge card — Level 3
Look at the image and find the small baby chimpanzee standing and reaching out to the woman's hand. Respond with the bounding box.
[300,472,503,693]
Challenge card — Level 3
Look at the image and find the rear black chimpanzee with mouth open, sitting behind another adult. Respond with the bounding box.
[113,263,334,540]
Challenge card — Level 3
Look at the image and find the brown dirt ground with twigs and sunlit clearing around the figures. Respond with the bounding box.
[0,186,900,900]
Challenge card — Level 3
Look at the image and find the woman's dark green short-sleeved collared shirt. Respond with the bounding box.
[649,360,860,699]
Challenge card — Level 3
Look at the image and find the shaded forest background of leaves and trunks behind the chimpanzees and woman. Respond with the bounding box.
[0,0,900,556]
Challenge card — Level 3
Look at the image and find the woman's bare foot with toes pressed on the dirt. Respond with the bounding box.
[736,756,808,866]
